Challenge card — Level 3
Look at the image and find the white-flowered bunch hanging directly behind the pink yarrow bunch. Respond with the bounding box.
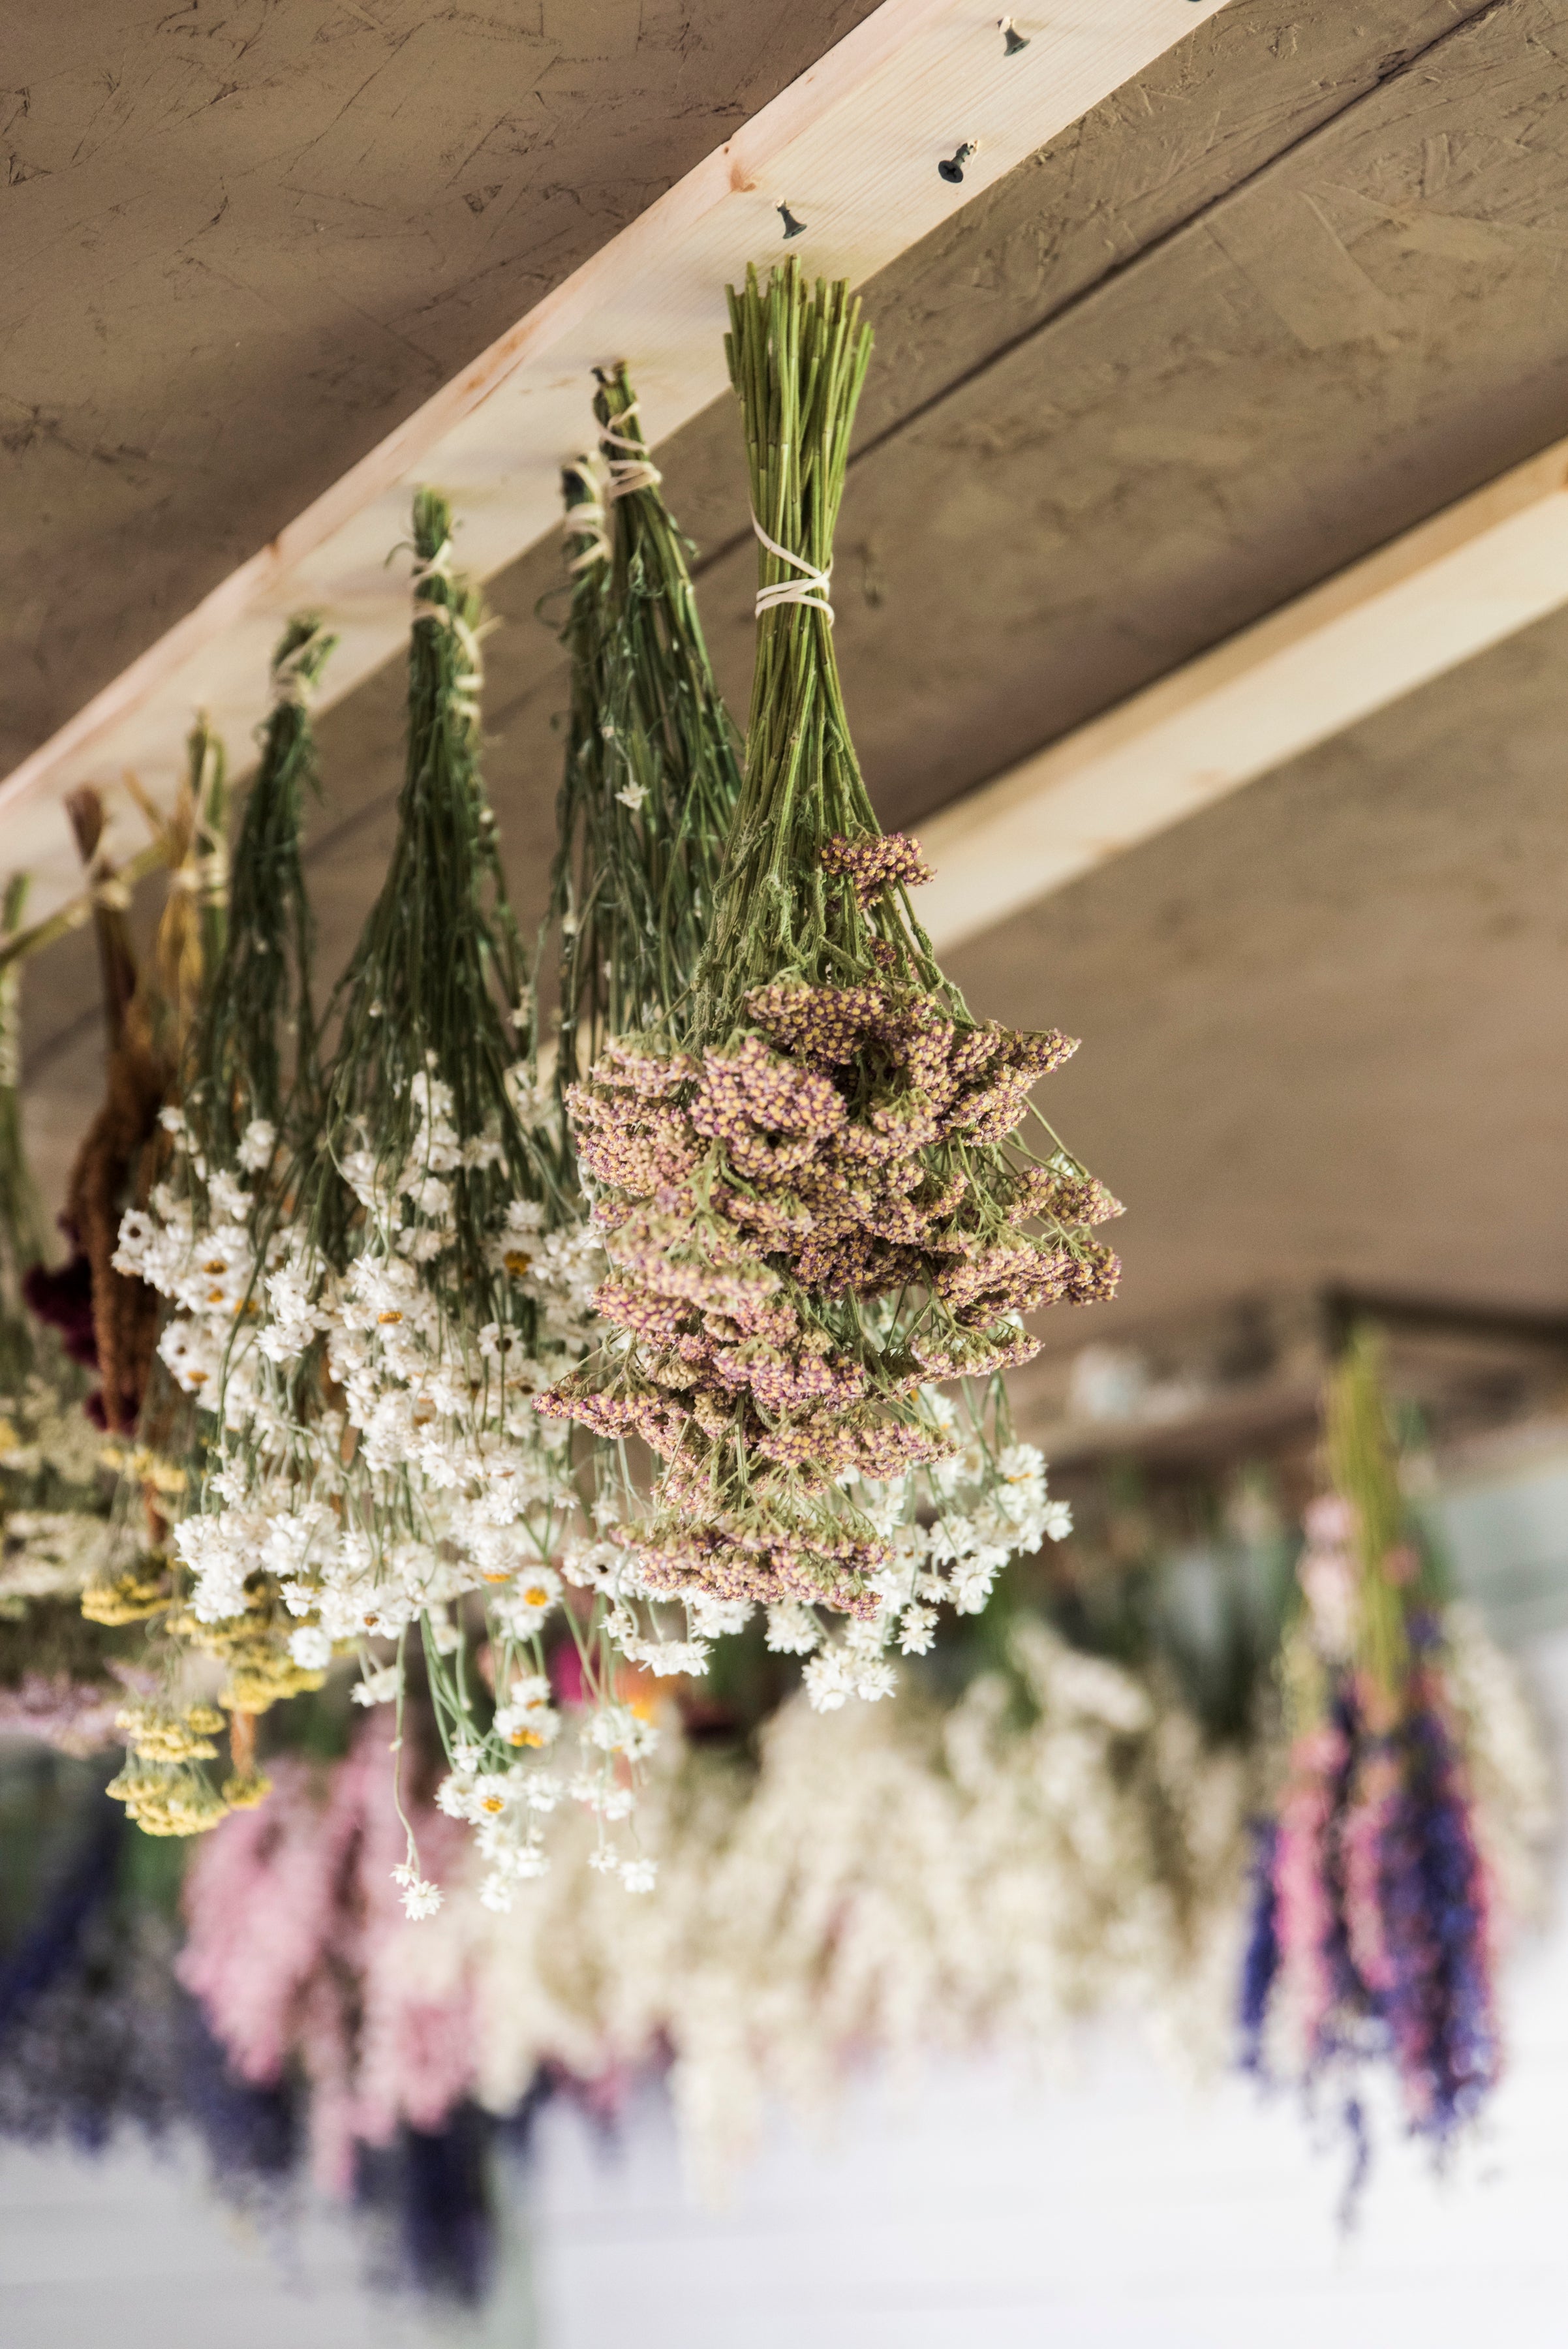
[542,369,1068,1708]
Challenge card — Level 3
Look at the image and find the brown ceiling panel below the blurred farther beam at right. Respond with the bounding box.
[951,592,1568,1346]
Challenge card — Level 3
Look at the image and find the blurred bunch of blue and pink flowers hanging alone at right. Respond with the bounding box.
[1242,1334,1545,2199]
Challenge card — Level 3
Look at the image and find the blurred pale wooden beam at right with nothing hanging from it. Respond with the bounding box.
[920,442,1568,949]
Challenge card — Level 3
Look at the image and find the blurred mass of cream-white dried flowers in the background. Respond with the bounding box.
[399,1623,1258,2187]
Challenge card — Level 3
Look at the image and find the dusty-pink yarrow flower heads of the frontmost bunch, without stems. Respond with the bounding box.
[538,838,1120,1616]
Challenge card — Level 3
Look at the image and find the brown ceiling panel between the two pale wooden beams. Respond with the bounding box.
[254,0,1568,944]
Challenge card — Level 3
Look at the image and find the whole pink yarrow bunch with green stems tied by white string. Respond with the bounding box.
[542,266,1117,1682]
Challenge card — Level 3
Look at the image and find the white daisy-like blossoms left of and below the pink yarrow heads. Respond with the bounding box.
[117,1069,1070,1917]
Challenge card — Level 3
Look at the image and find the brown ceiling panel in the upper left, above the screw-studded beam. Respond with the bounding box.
[0,0,876,771]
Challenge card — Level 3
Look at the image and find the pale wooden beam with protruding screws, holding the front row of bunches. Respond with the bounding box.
[0,0,1225,934]
